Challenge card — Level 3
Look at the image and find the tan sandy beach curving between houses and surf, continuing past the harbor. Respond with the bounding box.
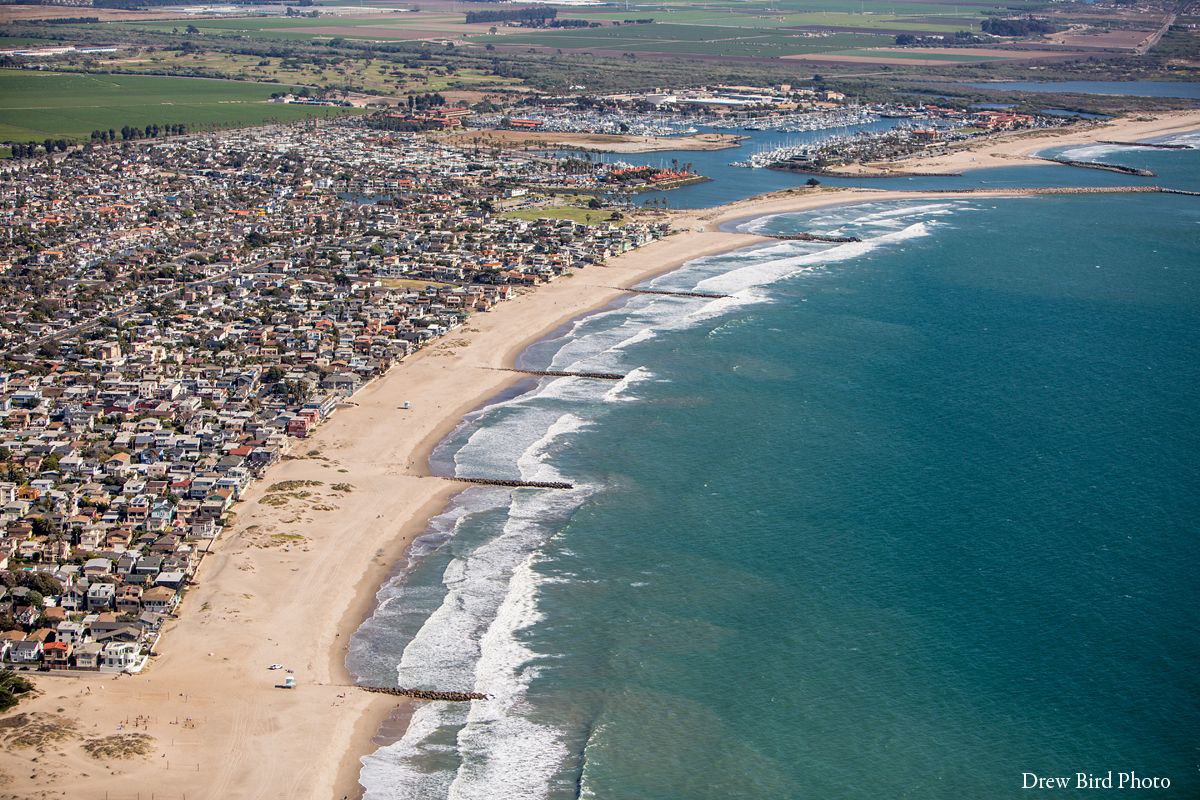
[0,112,1200,800]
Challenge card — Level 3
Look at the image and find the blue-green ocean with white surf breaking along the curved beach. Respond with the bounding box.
[349,140,1200,800]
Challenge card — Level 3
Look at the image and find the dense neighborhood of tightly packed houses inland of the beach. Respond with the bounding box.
[0,115,667,672]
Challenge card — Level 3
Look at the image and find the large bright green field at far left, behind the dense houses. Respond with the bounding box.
[0,70,354,142]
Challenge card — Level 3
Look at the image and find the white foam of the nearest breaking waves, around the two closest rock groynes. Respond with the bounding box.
[362,414,593,800]
